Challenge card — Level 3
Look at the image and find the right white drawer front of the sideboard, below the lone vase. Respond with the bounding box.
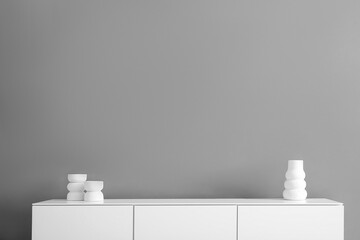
[238,206,344,240]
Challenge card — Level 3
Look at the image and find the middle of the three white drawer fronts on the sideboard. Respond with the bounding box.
[134,206,236,240]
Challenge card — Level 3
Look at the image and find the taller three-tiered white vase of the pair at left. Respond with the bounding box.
[66,174,87,201]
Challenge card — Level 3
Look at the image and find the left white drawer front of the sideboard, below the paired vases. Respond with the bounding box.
[32,206,133,240]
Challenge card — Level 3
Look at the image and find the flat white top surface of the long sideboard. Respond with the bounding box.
[33,198,343,206]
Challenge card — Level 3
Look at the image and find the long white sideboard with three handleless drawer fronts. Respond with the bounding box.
[32,199,344,240]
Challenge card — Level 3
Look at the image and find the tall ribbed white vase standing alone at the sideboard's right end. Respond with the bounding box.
[283,160,307,201]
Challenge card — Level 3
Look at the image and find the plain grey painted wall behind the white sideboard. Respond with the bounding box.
[0,0,360,240]
